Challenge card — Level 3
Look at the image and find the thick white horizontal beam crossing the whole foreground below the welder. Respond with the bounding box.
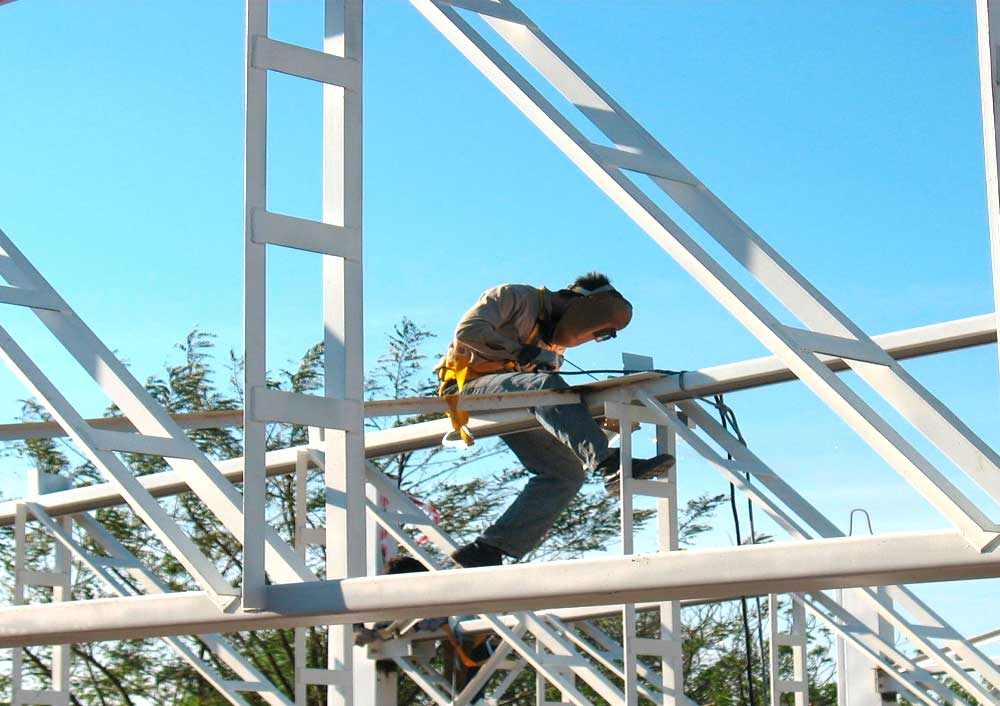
[0,530,1000,648]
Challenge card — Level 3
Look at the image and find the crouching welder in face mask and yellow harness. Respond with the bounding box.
[436,272,674,567]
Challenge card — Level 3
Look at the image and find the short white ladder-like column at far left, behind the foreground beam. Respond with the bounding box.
[11,468,73,706]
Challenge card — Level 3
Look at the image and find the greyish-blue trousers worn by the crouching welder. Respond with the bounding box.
[462,373,610,558]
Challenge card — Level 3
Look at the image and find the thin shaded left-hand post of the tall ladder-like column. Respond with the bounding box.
[242,0,268,610]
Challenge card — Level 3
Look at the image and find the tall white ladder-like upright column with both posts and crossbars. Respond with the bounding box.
[242,0,366,706]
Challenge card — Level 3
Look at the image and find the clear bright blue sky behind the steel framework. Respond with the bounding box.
[0,0,1000,644]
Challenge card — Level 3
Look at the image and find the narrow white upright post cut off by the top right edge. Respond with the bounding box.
[976,0,1000,384]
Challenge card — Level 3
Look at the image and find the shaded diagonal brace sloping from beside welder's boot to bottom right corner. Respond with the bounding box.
[632,392,1000,704]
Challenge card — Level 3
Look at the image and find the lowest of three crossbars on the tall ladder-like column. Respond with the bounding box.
[250,387,364,433]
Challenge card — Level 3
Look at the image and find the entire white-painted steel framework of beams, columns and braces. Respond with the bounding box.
[0,0,1000,706]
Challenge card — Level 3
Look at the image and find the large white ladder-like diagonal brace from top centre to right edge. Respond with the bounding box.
[411,0,1000,551]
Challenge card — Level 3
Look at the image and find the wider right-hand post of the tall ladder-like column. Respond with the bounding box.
[323,0,366,706]
